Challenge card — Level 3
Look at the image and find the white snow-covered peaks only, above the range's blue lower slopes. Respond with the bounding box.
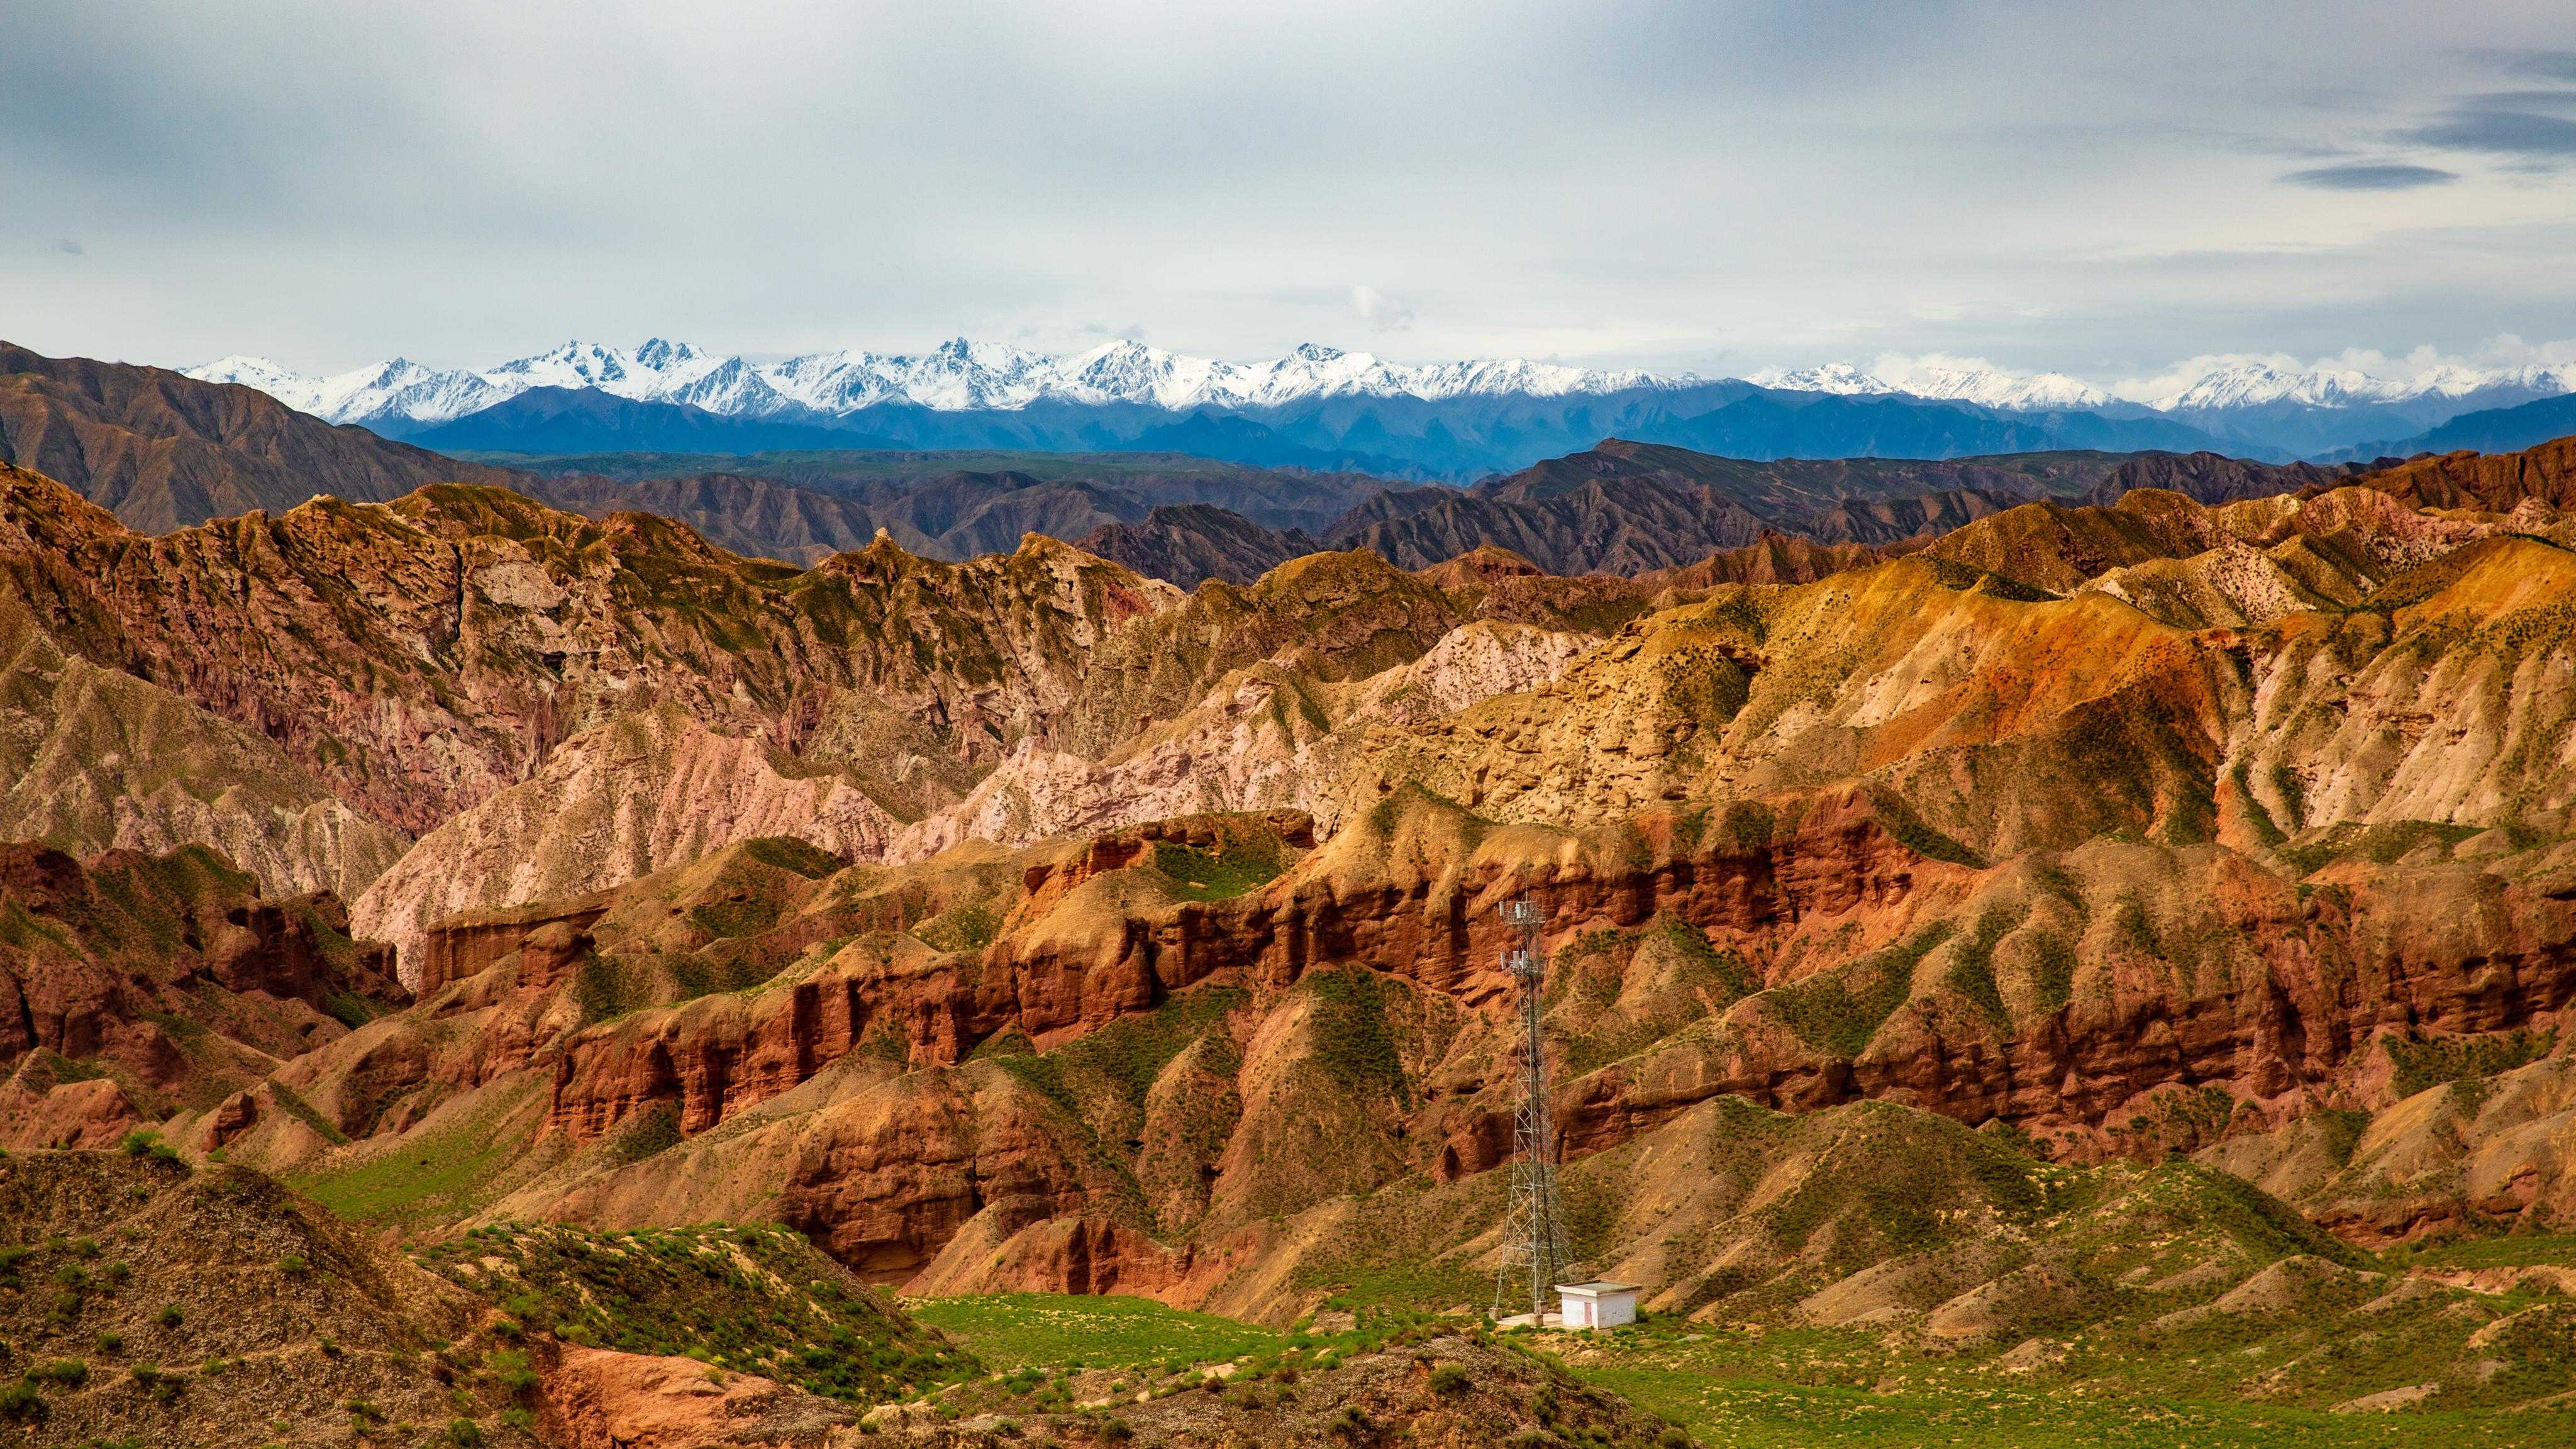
[186,338,2576,433]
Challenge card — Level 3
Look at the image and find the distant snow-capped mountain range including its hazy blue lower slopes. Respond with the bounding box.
[188,338,2576,464]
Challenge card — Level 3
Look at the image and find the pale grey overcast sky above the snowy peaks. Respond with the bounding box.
[0,0,2576,382]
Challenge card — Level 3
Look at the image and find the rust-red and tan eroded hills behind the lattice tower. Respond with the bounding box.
[0,360,2576,1402]
